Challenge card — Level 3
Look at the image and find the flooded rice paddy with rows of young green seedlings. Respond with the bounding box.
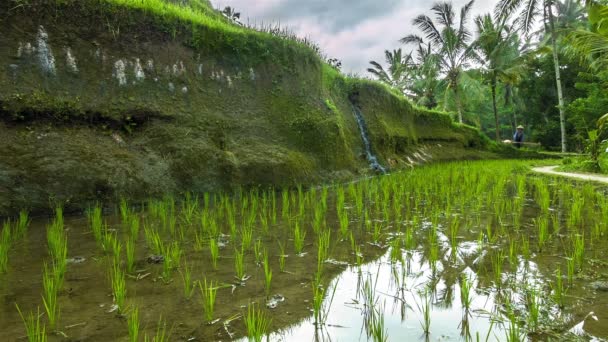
[0,161,608,341]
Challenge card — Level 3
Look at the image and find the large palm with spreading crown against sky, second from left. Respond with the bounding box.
[401,0,475,123]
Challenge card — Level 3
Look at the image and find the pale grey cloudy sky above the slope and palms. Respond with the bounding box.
[212,0,498,75]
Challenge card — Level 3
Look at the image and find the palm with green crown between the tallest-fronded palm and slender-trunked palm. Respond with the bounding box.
[474,14,523,141]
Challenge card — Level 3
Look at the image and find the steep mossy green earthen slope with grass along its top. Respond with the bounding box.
[0,0,498,215]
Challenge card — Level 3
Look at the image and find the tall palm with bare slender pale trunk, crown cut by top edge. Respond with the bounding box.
[496,0,567,152]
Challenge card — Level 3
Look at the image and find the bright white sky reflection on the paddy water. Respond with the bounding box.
[270,253,504,341]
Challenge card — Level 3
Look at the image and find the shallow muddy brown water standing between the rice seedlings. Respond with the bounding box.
[0,164,608,341]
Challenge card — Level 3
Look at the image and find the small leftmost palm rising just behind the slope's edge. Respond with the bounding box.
[367,49,412,93]
